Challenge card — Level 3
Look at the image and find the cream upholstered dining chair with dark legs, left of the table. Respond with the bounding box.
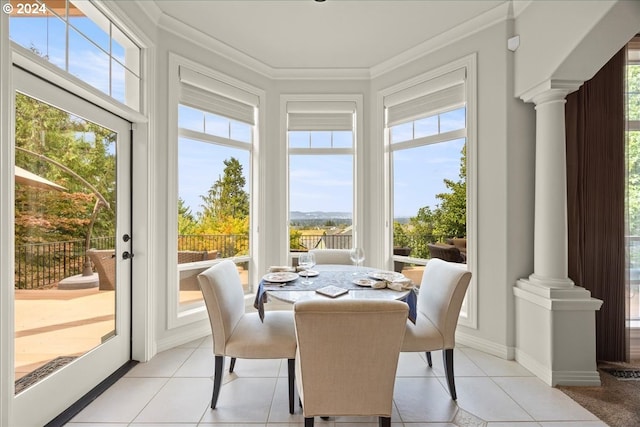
[198,260,296,414]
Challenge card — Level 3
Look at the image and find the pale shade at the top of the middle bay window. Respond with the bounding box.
[287,101,356,131]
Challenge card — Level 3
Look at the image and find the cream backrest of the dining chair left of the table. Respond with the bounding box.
[198,260,244,356]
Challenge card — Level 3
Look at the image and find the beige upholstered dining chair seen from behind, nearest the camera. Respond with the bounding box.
[293,299,408,427]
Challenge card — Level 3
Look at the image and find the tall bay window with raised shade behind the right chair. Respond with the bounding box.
[382,58,475,326]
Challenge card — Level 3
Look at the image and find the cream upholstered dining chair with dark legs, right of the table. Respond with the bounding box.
[402,258,471,400]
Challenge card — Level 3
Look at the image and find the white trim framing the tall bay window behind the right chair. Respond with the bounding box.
[376,53,478,329]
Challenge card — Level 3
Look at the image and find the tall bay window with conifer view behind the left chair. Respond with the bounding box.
[177,66,258,308]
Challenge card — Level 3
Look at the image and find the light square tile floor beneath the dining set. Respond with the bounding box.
[67,336,606,427]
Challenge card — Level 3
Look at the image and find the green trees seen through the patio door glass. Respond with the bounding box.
[15,94,116,245]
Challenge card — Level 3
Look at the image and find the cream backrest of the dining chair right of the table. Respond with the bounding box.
[418,258,471,349]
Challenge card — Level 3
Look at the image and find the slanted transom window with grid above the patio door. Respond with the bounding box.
[9,0,140,110]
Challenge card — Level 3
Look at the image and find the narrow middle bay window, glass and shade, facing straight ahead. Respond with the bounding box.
[286,100,356,252]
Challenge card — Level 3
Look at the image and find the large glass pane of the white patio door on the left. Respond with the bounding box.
[14,93,116,393]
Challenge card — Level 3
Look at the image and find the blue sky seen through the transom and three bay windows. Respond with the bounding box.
[10,8,464,222]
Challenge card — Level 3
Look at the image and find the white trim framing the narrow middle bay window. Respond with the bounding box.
[280,94,366,259]
